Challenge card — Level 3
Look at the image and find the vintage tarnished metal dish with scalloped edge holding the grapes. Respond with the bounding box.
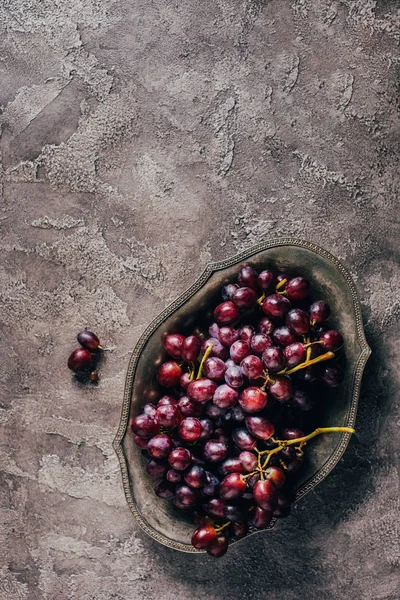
[113,238,371,552]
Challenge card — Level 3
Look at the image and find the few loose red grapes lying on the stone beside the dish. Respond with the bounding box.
[67,329,103,383]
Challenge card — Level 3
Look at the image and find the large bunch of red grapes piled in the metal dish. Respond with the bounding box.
[131,266,353,557]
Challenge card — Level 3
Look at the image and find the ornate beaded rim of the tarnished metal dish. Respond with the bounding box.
[113,238,372,554]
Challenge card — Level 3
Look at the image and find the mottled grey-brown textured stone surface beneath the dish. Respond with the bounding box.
[0,0,400,600]
